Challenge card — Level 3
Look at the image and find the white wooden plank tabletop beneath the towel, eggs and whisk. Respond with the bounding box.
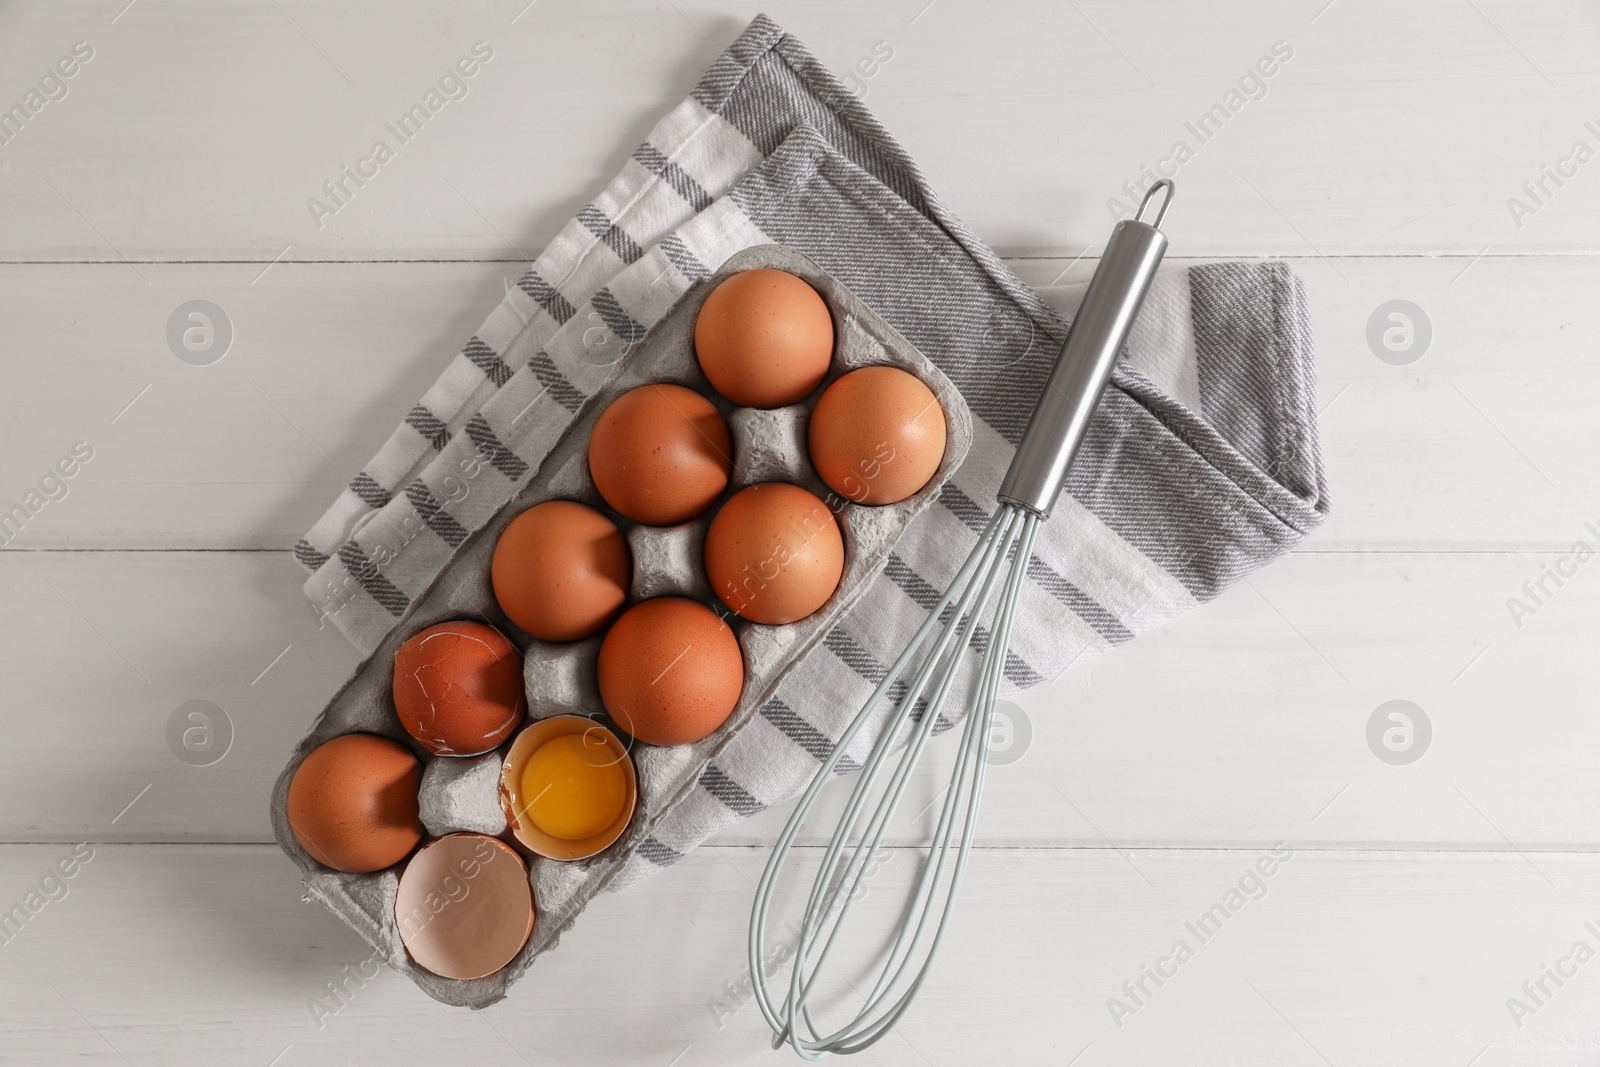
[0,0,1600,1067]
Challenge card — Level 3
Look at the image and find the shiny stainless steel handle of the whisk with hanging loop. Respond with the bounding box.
[998,178,1173,518]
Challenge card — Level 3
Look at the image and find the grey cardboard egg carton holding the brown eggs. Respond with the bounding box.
[272,245,973,1008]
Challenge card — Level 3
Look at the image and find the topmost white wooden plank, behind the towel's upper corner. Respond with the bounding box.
[0,0,1600,262]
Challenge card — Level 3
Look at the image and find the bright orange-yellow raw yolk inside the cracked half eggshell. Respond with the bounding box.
[522,734,627,841]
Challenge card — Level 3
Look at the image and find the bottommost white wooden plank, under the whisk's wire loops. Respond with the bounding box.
[0,841,1600,1067]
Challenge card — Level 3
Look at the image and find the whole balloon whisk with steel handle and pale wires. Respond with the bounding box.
[749,179,1173,1059]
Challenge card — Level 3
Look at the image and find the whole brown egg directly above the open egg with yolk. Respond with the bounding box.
[600,597,744,745]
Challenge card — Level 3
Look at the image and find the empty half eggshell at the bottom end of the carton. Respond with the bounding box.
[395,833,534,979]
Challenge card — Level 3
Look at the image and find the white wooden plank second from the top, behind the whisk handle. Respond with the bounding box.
[0,255,1600,552]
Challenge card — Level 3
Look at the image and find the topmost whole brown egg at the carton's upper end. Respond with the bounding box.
[694,270,834,408]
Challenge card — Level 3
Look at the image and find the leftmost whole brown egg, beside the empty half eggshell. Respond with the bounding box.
[288,734,422,873]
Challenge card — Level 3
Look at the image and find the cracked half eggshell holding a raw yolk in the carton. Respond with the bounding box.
[501,715,638,859]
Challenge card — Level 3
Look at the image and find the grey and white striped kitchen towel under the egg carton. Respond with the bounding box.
[294,16,1328,886]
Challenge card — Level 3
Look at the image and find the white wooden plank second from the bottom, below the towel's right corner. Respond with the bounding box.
[0,552,1600,849]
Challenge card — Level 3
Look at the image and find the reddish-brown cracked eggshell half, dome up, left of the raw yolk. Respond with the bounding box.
[394,621,523,755]
